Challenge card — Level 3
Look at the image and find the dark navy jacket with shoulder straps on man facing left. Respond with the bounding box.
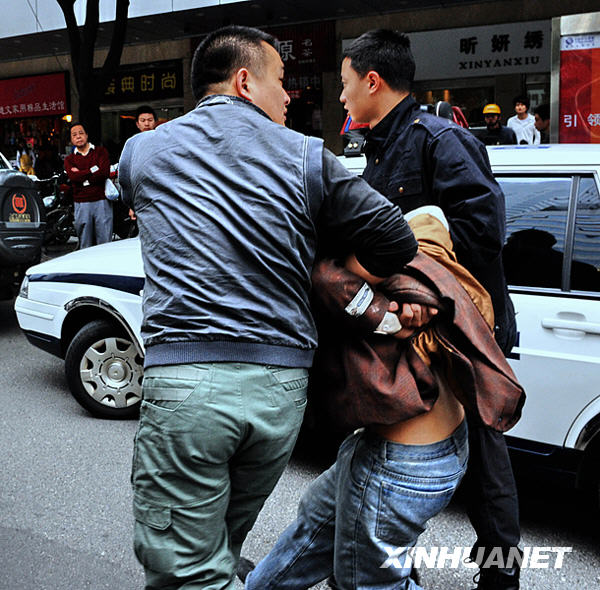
[363,97,516,353]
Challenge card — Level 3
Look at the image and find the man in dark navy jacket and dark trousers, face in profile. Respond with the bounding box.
[340,30,520,590]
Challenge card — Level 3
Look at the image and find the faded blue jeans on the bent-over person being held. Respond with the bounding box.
[246,421,469,590]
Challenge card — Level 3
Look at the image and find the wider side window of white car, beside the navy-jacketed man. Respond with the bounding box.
[497,175,572,289]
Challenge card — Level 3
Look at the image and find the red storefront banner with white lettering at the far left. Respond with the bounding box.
[0,72,67,119]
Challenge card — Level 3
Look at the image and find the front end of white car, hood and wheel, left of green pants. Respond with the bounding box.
[15,238,144,418]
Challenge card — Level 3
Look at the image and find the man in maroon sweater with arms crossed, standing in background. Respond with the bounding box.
[64,122,113,248]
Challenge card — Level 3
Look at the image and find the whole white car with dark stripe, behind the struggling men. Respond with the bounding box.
[15,145,600,500]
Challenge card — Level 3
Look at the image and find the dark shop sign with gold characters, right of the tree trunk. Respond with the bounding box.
[101,60,183,104]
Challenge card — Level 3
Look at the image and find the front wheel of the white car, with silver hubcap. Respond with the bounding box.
[65,320,143,418]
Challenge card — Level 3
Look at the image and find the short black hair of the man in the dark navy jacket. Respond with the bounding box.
[342,29,415,92]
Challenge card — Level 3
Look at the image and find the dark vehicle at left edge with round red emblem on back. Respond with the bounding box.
[0,154,45,299]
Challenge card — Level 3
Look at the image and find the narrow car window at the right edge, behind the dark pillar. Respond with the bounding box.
[571,176,600,291]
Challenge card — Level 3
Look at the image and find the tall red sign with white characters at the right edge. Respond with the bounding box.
[558,34,600,143]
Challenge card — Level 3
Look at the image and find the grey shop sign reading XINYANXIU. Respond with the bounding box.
[343,20,551,80]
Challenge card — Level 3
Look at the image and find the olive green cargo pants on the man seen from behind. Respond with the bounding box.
[131,363,308,590]
